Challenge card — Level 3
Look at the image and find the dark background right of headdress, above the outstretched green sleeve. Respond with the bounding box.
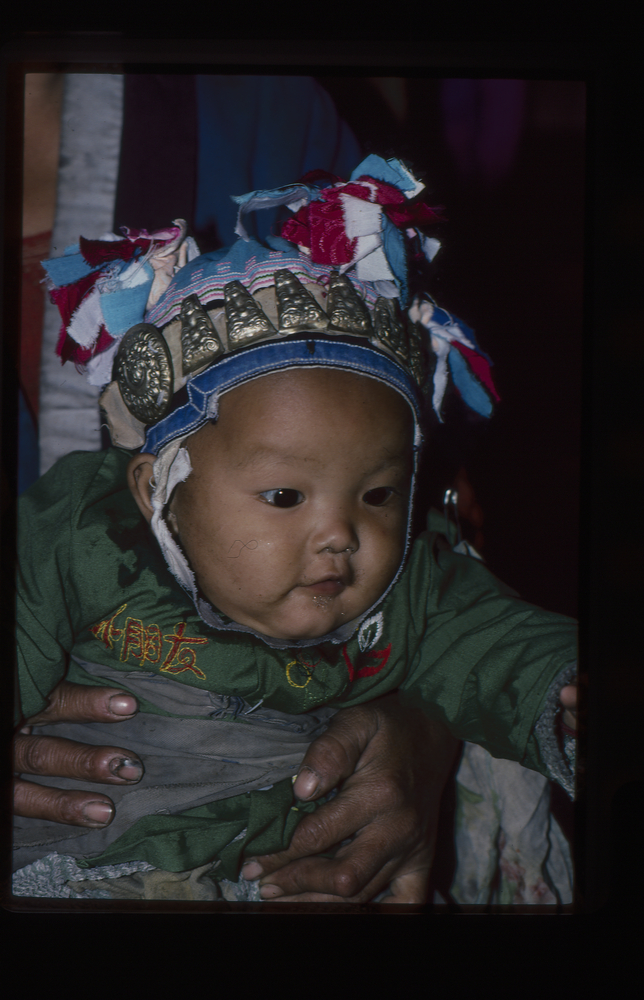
[317,74,586,616]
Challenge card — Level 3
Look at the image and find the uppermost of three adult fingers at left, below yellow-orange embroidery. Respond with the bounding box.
[26,681,139,725]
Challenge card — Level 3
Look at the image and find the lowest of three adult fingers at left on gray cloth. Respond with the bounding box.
[14,778,114,827]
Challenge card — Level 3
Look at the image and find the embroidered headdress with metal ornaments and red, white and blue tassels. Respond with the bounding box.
[44,155,498,645]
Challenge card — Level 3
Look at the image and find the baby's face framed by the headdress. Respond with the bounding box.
[168,368,413,640]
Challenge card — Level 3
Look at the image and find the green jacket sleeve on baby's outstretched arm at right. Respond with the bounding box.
[402,536,577,777]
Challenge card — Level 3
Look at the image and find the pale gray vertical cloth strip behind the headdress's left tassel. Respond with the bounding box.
[39,73,123,475]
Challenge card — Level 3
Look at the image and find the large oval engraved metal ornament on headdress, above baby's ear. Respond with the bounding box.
[114,323,174,425]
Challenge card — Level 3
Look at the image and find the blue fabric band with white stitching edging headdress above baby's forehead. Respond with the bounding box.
[141,335,422,455]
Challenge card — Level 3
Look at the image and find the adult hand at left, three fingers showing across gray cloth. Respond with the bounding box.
[14,681,143,827]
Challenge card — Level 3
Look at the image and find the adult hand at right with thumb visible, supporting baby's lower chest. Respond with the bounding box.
[242,695,460,903]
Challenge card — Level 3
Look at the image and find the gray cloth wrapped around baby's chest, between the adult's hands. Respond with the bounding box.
[14,660,335,870]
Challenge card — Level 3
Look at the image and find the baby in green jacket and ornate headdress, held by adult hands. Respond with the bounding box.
[15,157,576,898]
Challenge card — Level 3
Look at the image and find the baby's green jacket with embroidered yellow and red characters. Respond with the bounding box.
[16,449,576,878]
